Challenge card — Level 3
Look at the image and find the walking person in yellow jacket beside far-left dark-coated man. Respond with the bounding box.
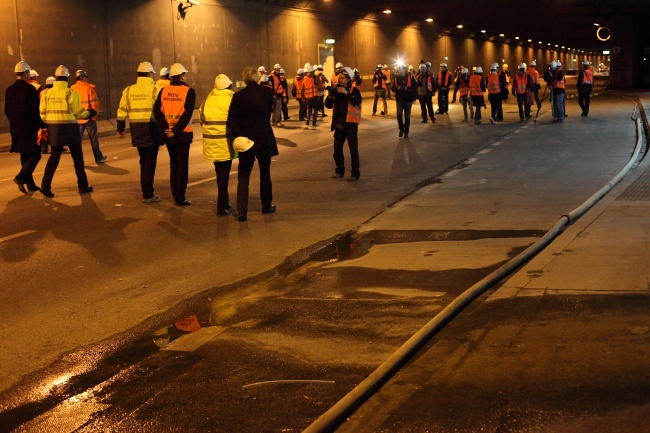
[39,65,97,198]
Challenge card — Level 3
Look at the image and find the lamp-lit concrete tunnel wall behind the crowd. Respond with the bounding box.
[0,0,600,132]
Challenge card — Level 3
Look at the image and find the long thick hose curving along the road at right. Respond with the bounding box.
[303,99,643,433]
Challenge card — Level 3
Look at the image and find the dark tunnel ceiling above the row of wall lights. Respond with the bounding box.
[247,0,650,51]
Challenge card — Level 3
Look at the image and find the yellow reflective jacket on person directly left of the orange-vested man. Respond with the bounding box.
[117,77,160,123]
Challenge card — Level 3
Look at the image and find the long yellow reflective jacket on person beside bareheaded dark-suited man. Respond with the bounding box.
[199,89,234,161]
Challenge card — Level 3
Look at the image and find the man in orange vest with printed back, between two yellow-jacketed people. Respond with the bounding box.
[153,63,196,206]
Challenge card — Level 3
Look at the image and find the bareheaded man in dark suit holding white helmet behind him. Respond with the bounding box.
[227,67,278,221]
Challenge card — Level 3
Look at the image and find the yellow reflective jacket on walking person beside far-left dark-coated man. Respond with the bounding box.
[39,81,90,124]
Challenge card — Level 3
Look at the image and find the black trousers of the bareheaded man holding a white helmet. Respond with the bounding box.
[237,149,273,214]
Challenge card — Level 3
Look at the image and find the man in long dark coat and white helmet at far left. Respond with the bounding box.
[5,62,45,194]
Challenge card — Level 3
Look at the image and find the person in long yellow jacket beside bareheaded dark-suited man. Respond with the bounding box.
[199,74,235,216]
